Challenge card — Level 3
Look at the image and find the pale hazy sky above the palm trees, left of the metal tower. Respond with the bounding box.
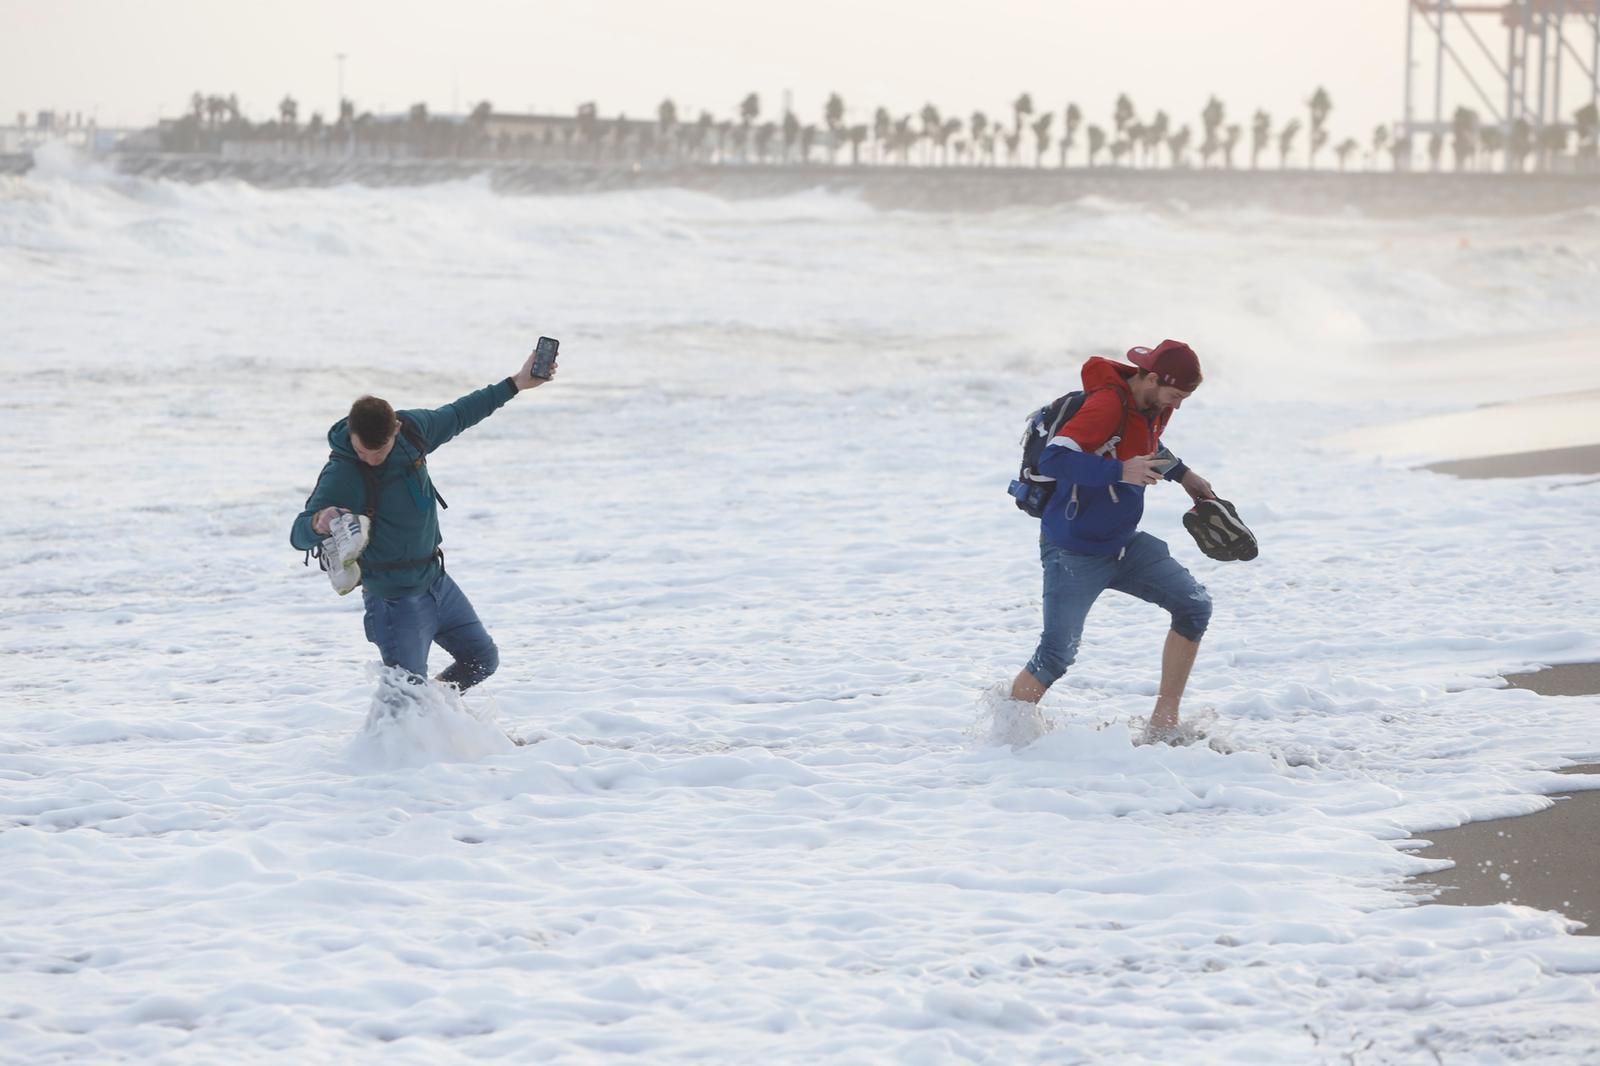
[0,0,1472,144]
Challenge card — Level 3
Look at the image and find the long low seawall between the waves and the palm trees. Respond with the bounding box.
[12,154,1600,218]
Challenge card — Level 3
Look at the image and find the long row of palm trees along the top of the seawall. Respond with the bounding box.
[163,86,1600,171]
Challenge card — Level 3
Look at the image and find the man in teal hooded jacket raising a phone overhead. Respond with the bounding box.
[290,348,554,688]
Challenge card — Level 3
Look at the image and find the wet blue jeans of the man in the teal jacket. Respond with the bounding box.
[362,573,499,688]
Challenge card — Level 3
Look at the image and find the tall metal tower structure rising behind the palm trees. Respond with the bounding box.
[1398,0,1600,170]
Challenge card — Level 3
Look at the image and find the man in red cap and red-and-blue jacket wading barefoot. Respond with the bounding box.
[1011,341,1214,741]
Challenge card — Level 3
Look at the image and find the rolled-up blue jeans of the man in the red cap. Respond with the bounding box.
[1027,533,1211,688]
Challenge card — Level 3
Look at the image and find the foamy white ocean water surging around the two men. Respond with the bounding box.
[9,158,1600,1064]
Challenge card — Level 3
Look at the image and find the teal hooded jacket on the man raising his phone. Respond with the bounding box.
[290,378,517,599]
